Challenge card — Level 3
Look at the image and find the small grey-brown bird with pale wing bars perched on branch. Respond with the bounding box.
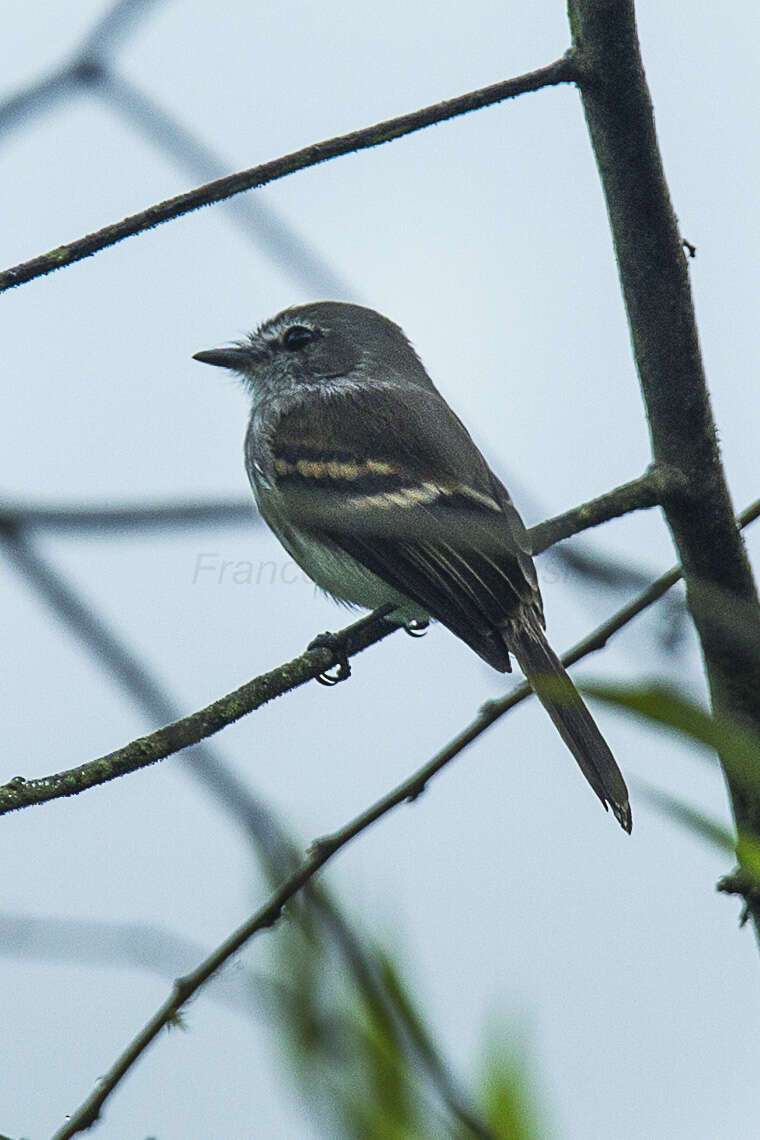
[195,301,631,831]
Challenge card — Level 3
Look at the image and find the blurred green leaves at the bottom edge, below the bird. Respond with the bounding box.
[252,886,551,1140]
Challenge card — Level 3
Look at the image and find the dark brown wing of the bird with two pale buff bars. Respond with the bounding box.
[269,384,541,671]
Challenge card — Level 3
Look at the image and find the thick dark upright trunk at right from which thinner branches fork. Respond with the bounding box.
[569,0,760,934]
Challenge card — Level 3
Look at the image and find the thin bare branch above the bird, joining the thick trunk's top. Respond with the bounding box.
[0,56,575,293]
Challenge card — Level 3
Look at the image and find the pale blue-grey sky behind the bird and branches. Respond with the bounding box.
[0,0,760,1140]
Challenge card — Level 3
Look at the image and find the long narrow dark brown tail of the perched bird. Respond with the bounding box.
[509,619,632,833]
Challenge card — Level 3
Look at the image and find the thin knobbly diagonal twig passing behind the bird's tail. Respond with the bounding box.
[52,499,760,1140]
